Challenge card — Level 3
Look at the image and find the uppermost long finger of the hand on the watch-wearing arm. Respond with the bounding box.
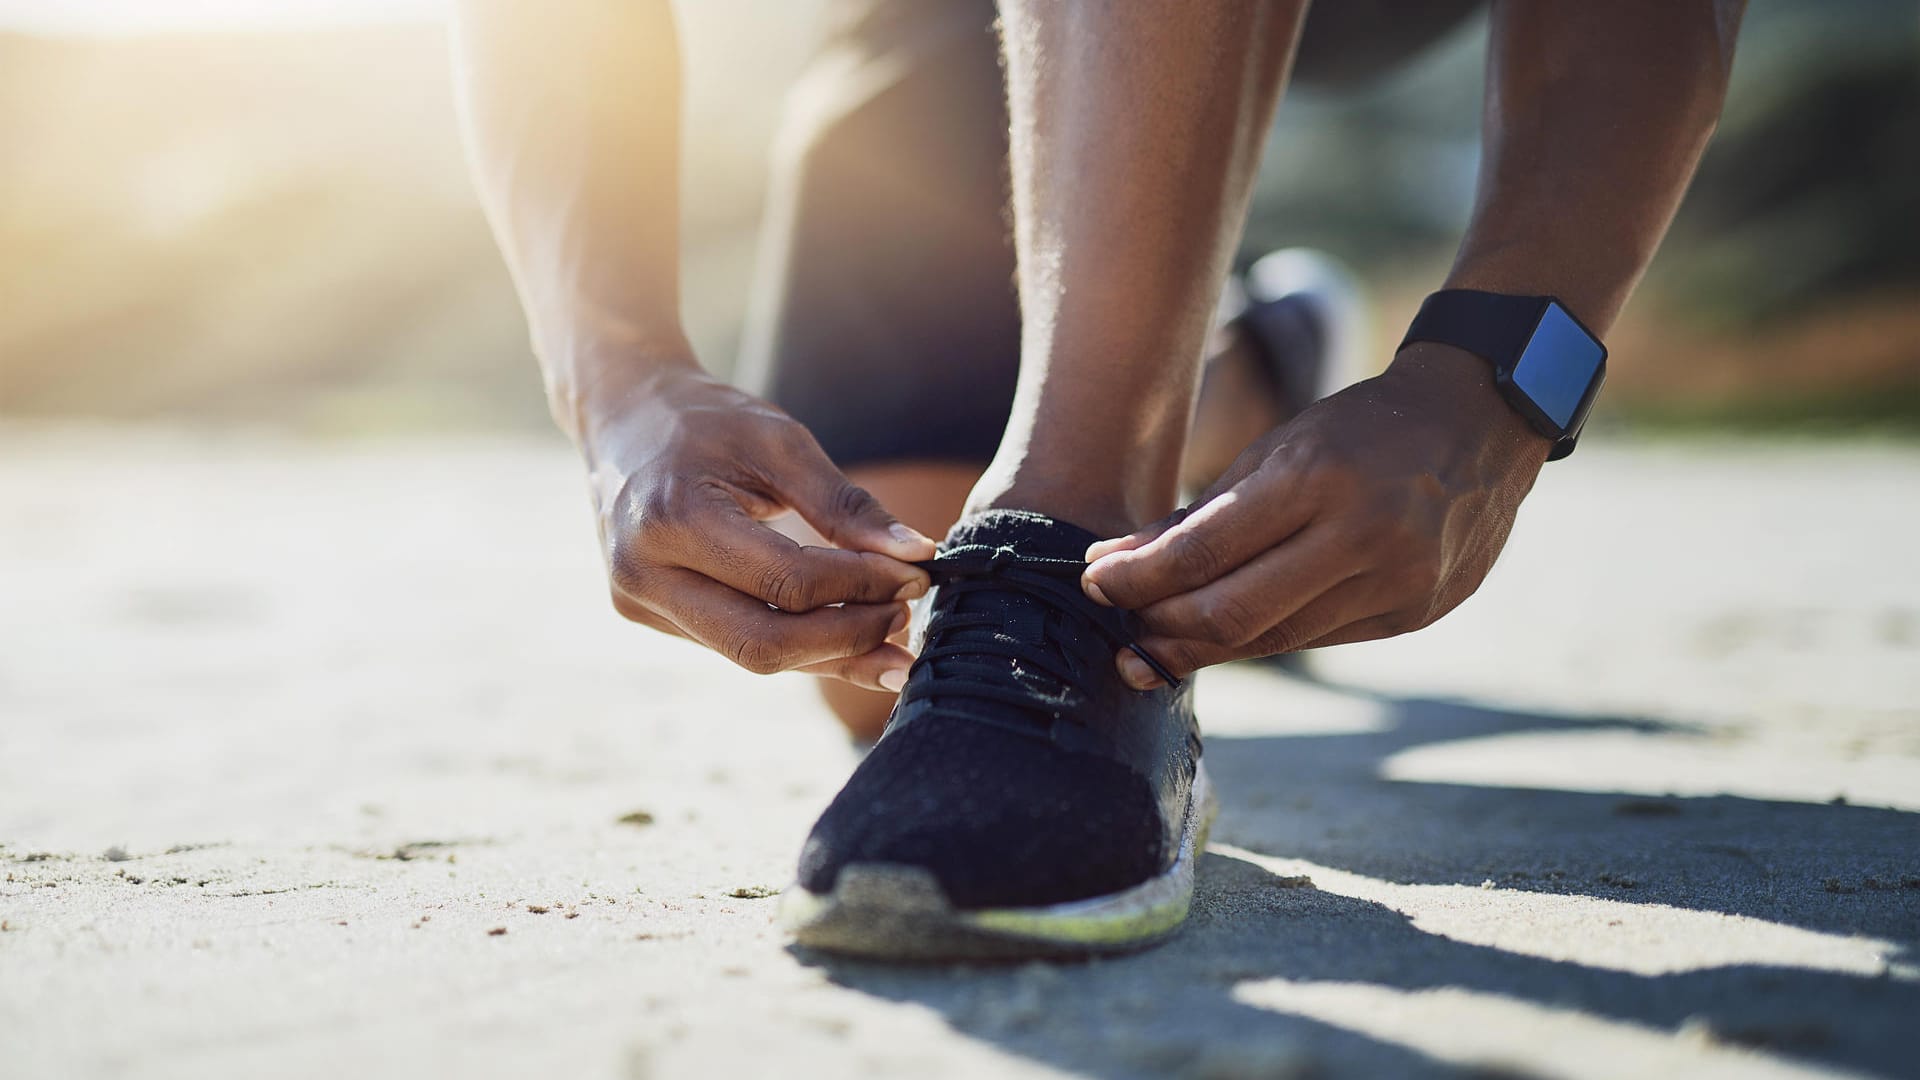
[1081,469,1313,609]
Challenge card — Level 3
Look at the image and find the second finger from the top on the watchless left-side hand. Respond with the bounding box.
[655,490,929,611]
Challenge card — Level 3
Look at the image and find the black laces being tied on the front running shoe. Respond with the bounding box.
[918,544,1181,715]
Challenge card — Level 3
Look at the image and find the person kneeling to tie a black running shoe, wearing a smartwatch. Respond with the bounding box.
[455,0,1741,959]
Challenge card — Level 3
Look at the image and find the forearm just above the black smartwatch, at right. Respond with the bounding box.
[1448,0,1743,334]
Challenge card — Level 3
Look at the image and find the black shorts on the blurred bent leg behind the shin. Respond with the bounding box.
[737,0,1480,469]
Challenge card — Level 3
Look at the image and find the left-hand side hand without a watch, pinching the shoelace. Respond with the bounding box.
[582,367,933,690]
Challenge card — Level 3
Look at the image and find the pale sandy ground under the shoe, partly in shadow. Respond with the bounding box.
[0,430,1920,1078]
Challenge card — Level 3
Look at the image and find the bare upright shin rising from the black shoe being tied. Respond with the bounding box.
[970,0,1304,536]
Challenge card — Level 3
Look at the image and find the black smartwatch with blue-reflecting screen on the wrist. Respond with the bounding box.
[1400,288,1607,461]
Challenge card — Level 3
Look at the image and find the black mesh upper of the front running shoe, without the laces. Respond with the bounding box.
[801,513,1169,909]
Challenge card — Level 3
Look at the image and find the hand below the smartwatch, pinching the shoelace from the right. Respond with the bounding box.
[1081,344,1551,690]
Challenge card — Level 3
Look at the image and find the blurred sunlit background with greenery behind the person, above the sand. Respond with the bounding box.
[0,0,1920,434]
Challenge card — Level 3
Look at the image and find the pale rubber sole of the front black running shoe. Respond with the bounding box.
[780,763,1219,961]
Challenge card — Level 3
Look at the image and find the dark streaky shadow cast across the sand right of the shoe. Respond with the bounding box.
[801,664,1920,1076]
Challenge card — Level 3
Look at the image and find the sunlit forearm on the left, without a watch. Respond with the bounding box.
[453,0,693,440]
